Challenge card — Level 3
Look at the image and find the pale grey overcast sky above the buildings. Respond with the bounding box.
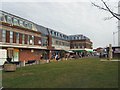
[0,0,118,48]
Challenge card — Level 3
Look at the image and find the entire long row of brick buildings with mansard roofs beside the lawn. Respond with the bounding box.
[0,11,92,61]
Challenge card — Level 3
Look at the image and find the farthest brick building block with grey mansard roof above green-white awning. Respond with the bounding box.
[69,34,93,56]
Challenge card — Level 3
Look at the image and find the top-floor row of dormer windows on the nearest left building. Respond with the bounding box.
[0,12,33,29]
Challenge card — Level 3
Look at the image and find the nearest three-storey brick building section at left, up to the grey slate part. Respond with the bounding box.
[0,11,41,61]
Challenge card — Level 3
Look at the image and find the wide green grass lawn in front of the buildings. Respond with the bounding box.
[3,58,118,88]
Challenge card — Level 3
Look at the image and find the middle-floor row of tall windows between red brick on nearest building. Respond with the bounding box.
[2,30,41,45]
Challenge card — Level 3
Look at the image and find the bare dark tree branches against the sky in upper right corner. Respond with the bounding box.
[91,0,120,20]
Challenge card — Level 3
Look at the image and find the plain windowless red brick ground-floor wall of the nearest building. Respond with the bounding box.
[19,49,41,61]
